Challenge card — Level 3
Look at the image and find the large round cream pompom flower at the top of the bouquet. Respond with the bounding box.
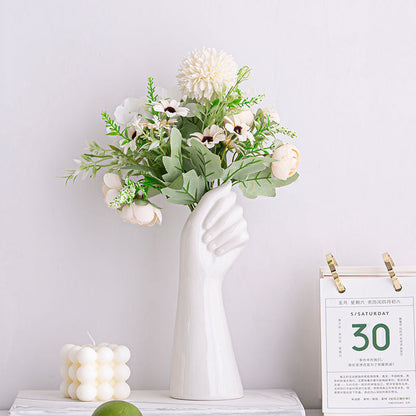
[177,48,238,101]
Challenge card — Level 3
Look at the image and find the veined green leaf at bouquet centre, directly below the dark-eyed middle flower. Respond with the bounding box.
[190,139,224,182]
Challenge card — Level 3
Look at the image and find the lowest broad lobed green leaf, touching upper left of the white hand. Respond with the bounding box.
[161,170,205,205]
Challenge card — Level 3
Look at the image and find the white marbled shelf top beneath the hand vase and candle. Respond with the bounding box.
[8,389,321,416]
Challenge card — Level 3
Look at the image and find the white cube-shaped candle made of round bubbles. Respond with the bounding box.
[60,343,130,402]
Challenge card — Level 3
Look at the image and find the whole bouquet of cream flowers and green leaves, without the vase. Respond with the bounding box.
[65,49,299,225]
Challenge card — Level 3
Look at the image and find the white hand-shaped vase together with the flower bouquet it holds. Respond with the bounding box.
[65,49,299,400]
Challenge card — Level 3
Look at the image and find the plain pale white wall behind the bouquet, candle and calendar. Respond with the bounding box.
[0,0,416,408]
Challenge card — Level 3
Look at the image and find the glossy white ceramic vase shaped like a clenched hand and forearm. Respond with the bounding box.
[170,183,248,400]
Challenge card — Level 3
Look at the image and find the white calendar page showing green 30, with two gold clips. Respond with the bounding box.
[320,256,416,415]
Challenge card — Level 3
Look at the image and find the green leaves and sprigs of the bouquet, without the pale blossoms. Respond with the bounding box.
[64,66,299,214]
